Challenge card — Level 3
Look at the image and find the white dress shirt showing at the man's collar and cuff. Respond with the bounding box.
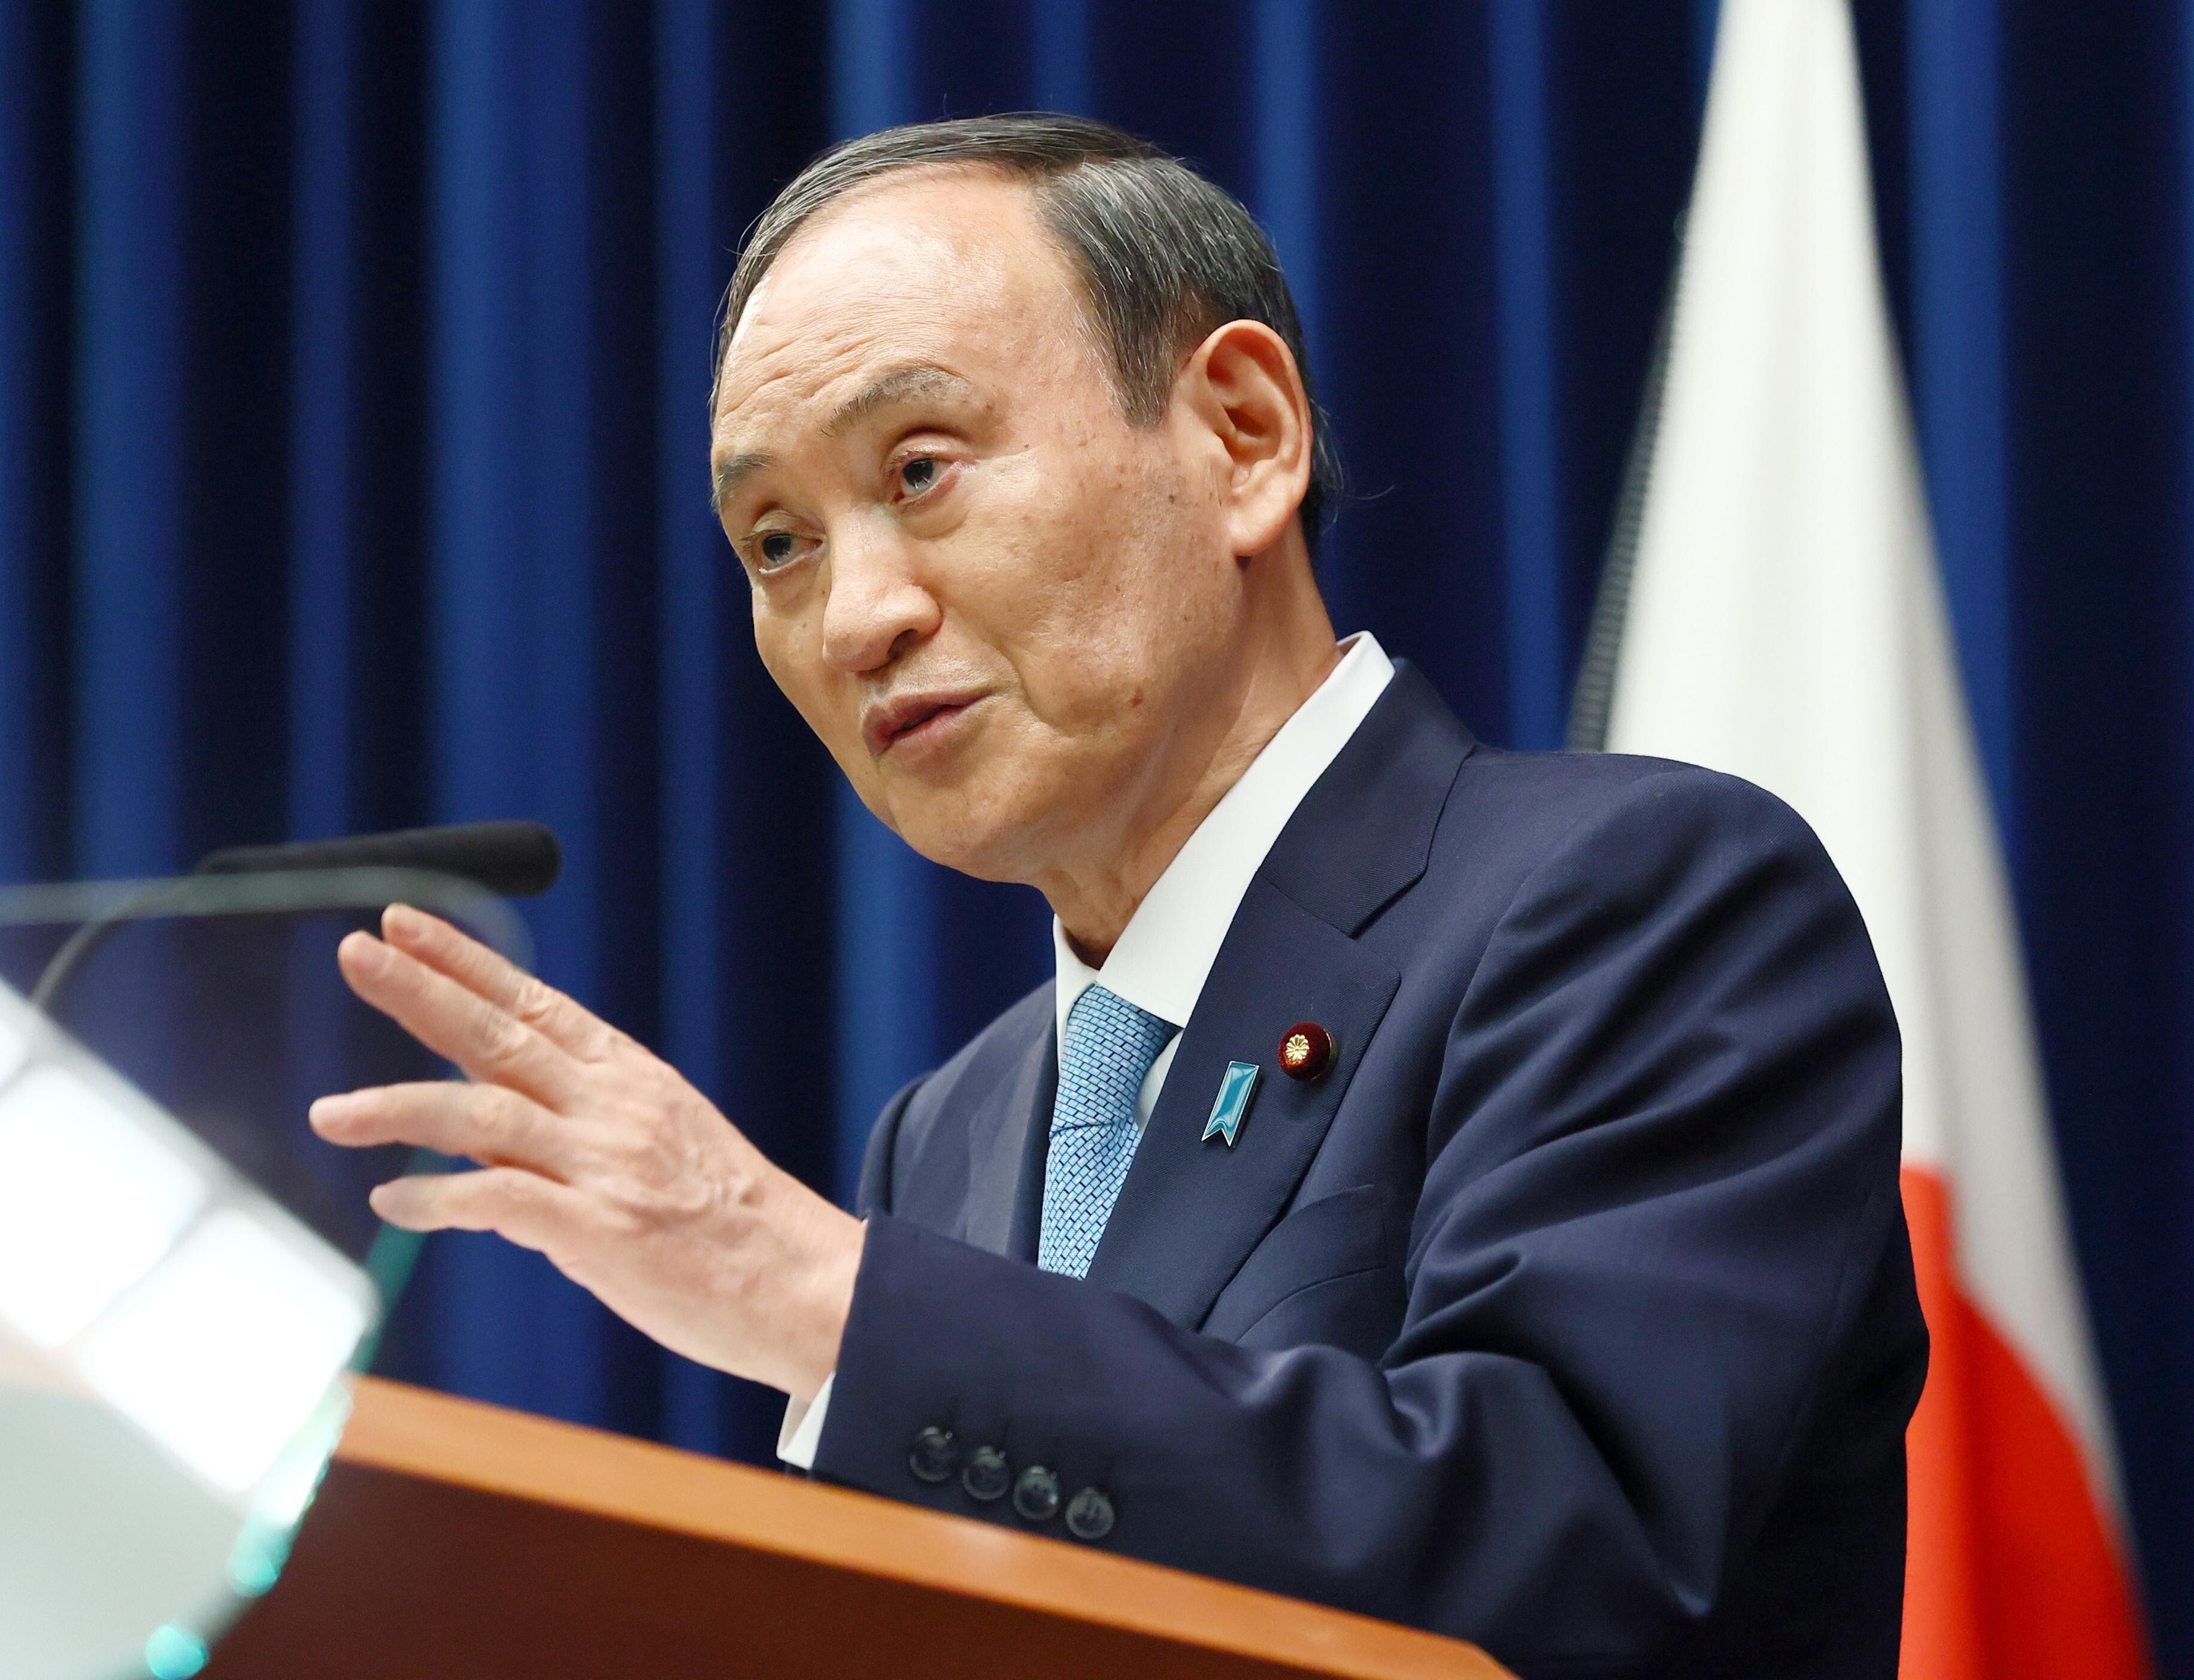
[777,632,1393,1469]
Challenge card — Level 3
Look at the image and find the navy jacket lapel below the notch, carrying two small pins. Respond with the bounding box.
[1088,880,1402,1329]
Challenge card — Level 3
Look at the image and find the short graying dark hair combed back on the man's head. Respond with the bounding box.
[708,112,1341,559]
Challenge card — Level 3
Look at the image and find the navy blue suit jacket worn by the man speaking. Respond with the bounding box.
[816,667,1926,1680]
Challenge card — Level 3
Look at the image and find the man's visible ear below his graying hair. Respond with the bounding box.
[1174,320,1312,557]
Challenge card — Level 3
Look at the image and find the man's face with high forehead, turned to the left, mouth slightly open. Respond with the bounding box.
[713,169,1244,884]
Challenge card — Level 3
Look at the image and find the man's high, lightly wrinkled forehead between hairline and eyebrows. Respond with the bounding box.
[715,169,1084,427]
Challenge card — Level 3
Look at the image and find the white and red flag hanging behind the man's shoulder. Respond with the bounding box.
[1608,0,2145,1680]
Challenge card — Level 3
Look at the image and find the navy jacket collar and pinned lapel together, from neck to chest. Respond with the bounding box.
[1071,665,1474,1329]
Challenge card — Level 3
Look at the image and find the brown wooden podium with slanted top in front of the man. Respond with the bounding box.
[206,1377,1505,1680]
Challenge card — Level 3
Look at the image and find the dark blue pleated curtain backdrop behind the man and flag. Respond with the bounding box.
[0,0,2194,1673]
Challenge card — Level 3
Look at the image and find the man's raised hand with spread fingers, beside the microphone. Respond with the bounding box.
[311,903,862,1399]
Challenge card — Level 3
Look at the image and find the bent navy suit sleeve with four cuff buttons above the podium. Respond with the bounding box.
[816,770,1909,1673]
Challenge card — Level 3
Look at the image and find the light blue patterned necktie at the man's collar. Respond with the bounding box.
[1035,985,1174,1276]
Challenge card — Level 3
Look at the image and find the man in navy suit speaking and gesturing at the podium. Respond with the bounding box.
[314,119,1926,1678]
